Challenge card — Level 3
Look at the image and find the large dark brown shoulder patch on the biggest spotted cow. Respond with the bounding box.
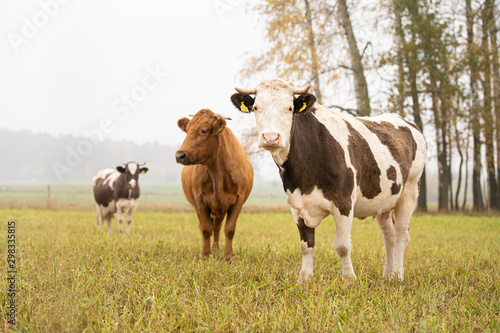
[280,108,354,216]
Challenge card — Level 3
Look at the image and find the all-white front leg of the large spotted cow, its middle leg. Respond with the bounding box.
[333,209,356,282]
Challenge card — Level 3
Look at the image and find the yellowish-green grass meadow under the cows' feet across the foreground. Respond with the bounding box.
[0,209,500,332]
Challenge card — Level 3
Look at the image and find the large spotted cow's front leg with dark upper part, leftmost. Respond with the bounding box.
[292,208,315,282]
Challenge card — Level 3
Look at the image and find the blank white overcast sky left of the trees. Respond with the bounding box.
[0,0,263,145]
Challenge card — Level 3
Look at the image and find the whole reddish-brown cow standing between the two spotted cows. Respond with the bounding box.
[175,109,253,261]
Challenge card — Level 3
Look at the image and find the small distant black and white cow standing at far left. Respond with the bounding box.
[92,162,148,233]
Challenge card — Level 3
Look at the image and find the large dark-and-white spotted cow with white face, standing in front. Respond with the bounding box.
[231,79,427,281]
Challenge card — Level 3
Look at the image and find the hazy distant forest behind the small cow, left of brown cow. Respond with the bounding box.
[0,128,182,182]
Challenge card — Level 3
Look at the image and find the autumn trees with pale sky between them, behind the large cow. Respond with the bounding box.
[240,0,500,212]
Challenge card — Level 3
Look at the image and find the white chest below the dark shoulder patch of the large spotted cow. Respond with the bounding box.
[286,187,334,228]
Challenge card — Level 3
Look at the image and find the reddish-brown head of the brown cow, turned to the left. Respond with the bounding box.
[175,109,230,165]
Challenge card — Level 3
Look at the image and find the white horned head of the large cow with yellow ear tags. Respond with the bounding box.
[231,79,316,164]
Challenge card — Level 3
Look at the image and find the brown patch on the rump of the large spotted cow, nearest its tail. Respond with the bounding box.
[359,119,417,184]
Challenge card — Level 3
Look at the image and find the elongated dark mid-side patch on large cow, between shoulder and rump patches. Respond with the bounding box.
[345,122,382,199]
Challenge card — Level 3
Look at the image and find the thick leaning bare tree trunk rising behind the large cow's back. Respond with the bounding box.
[338,0,371,116]
